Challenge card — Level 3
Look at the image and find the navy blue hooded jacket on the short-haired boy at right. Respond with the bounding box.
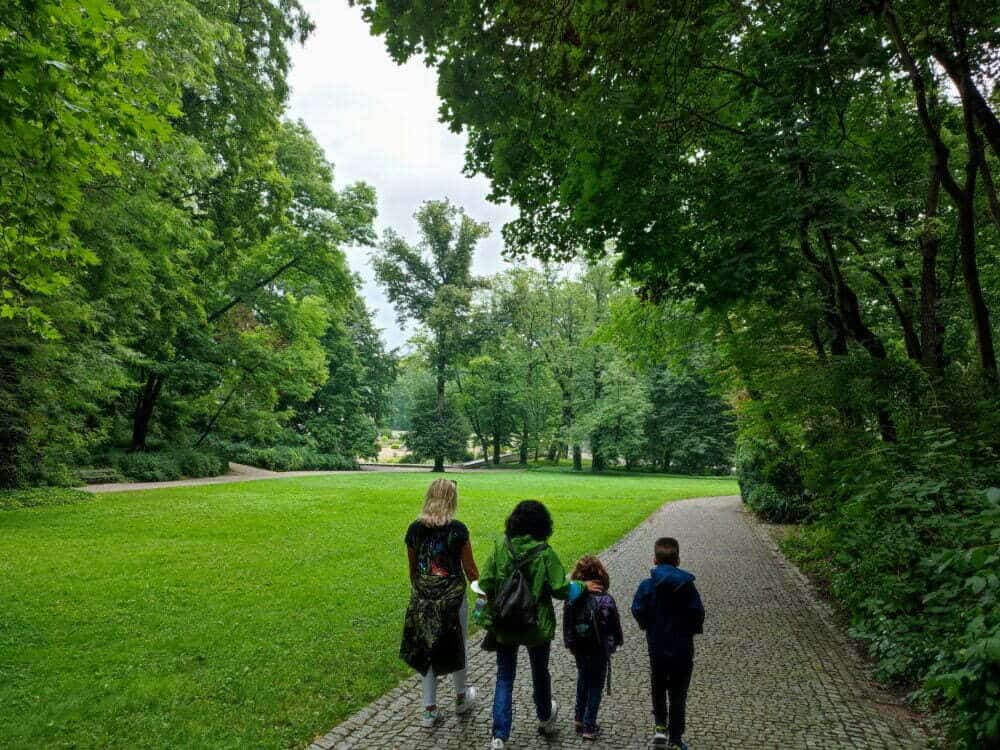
[632,564,705,658]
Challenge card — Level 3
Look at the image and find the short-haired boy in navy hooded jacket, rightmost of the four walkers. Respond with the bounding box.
[632,537,705,750]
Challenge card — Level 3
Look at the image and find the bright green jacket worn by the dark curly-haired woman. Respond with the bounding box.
[479,536,583,646]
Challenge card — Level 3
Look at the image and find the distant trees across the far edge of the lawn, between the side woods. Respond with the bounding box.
[374,201,733,474]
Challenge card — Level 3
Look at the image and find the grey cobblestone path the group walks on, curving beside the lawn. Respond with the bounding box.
[310,497,926,750]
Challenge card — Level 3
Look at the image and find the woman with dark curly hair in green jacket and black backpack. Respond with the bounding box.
[479,500,602,750]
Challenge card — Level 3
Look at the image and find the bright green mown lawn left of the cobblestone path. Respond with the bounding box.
[0,470,737,748]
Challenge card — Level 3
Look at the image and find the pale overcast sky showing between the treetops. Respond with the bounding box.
[288,0,514,347]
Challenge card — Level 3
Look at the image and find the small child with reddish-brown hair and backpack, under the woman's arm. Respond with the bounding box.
[563,555,623,740]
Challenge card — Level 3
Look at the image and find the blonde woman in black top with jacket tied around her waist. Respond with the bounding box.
[400,479,479,729]
